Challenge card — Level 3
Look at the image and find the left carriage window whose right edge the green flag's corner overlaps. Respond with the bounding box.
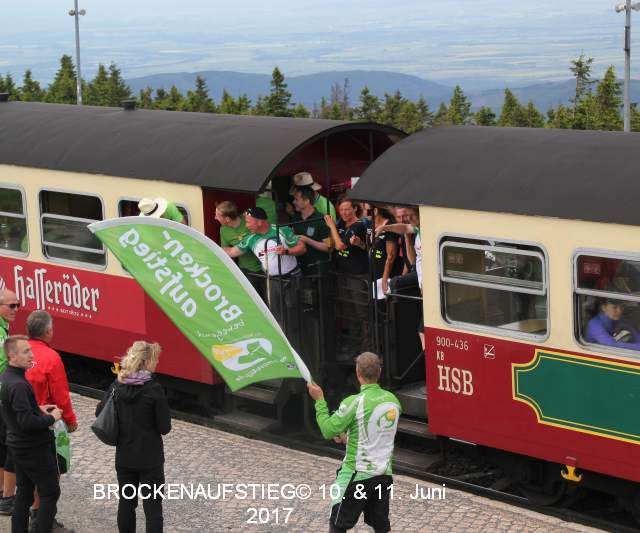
[40,190,107,266]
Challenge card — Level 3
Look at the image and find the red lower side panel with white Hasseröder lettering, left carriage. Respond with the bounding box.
[0,257,220,384]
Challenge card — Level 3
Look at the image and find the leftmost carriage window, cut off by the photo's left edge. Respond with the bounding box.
[0,186,29,255]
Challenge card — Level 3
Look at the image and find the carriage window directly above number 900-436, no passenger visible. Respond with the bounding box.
[440,237,548,338]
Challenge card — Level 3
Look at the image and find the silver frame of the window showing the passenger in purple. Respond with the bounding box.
[571,248,640,360]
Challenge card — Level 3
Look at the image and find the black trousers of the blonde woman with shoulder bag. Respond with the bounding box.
[116,465,164,533]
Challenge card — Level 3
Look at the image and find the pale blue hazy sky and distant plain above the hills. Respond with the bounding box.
[0,0,640,87]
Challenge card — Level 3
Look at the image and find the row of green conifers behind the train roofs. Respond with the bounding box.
[0,53,640,133]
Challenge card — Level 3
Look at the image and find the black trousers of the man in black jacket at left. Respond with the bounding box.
[9,439,60,533]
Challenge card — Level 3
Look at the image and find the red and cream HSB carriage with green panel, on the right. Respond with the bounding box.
[354,127,640,512]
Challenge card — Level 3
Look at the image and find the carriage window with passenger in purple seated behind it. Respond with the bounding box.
[573,253,640,356]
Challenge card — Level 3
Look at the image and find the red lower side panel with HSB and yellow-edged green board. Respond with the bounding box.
[425,328,640,481]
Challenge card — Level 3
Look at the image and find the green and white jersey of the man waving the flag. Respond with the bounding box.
[315,383,401,502]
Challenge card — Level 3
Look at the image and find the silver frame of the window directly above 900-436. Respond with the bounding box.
[438,233,551,343]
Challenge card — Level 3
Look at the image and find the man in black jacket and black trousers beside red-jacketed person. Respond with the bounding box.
[0,335,62,533]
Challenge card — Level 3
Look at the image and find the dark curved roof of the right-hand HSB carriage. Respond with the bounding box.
[351,126,640,225]
